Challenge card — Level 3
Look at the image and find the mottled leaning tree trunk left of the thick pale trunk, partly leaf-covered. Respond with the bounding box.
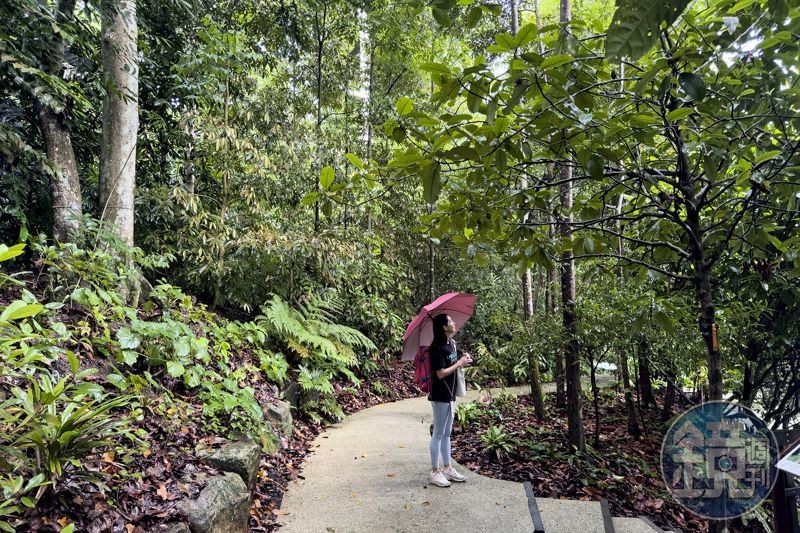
[36,0,83,241]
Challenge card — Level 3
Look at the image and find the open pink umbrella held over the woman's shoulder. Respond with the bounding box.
[400,292,478,361]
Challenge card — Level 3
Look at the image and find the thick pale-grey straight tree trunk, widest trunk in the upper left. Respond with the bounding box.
[99,0,139,245]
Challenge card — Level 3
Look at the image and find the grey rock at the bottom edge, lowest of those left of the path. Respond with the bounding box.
[178,472,250,533]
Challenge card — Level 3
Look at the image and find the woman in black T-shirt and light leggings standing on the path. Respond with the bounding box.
[428,313,472,487]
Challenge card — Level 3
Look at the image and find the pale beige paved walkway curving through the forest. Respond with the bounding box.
[279,376,610,533]
